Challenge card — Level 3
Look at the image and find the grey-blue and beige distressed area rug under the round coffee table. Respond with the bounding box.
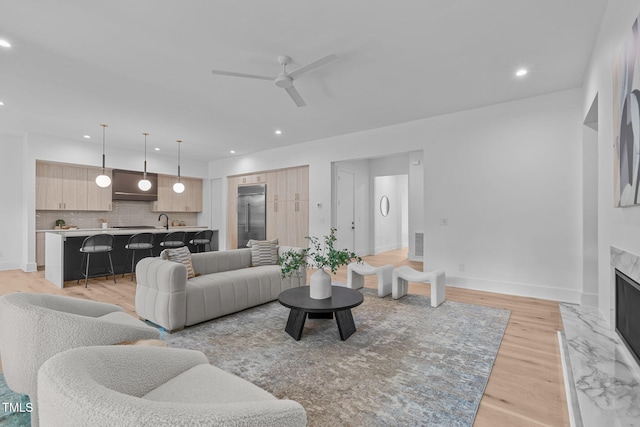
[164,289,510,427]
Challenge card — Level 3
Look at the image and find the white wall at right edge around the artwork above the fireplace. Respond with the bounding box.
[582,0,640,326]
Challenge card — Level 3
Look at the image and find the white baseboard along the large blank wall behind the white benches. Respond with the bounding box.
[446,275,581,304]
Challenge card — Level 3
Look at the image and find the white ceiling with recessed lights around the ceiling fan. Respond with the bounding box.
[0,0,606,160]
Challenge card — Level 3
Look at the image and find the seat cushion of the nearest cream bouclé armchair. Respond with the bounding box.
[142,364,276,404]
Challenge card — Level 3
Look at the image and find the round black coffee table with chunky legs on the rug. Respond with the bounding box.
[278,286,364,341]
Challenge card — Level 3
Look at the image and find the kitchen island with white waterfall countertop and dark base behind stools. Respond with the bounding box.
[44,227,218,288]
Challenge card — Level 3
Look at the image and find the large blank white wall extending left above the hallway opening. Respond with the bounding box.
[209,89,582,302]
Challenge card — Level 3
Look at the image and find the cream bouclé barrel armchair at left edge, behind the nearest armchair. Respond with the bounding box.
[0,292,160,427]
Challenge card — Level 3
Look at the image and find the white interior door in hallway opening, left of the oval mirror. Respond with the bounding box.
[336,170,355,251]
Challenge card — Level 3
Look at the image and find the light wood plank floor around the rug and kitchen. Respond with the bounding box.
[0,251,569,427]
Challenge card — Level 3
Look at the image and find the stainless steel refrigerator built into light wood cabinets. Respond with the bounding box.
[238,184,267,248]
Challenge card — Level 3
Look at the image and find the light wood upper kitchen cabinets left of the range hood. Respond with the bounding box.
[36,161,111,211]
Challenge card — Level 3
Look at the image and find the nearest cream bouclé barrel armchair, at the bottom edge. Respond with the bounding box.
[38,346,307,427]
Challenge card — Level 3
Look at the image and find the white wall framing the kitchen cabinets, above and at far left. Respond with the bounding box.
[0,133,211,271]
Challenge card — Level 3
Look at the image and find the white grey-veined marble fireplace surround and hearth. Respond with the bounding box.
[559,246,640,427]
